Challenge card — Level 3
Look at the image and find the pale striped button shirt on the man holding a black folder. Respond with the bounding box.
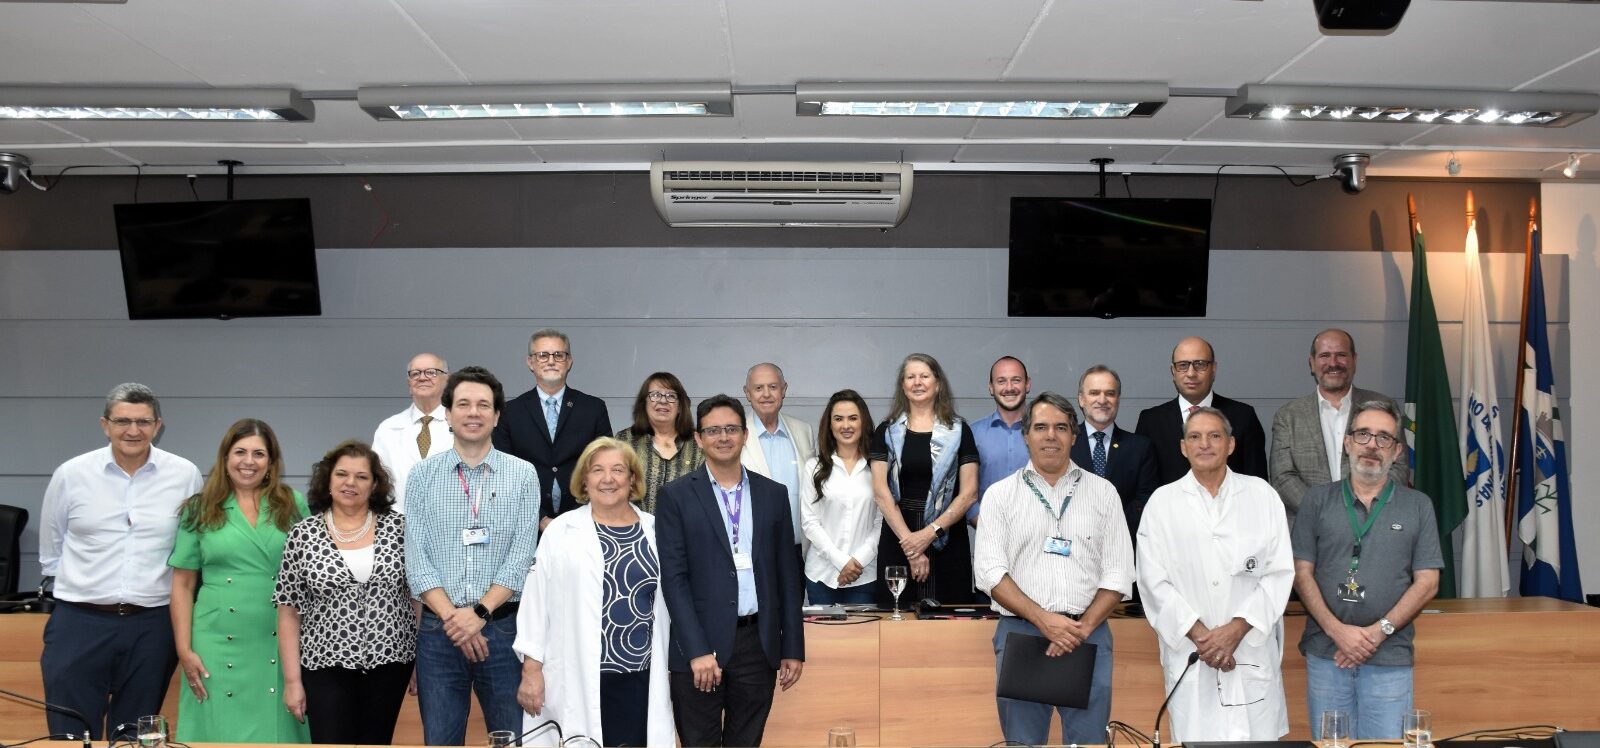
[973,460,1134,615]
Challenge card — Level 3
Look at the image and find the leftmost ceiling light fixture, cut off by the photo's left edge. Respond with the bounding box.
[0,86,315,121]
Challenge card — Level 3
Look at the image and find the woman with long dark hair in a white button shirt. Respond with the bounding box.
[800,390,883,606]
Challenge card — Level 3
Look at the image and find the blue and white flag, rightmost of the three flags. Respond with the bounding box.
[1517,229,1584,603]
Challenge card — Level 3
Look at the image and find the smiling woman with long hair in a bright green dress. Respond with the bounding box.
[166,419,310,743]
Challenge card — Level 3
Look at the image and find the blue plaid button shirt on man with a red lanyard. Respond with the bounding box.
[405,449,539,607]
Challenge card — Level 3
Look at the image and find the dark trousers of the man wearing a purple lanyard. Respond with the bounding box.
[668,623,778,748]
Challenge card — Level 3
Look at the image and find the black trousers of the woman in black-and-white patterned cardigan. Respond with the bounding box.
[301,662,411,745]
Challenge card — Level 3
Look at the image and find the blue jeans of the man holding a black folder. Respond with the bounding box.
[994,615,1110,745]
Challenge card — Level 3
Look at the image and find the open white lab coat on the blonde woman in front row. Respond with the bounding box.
[512,505,675,746]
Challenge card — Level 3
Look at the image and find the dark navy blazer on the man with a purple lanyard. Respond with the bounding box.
[656,468,805,673]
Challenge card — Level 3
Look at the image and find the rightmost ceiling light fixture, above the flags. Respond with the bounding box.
[1227,83,1600,128]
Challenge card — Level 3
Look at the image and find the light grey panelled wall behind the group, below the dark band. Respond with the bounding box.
[0,246,1568,587]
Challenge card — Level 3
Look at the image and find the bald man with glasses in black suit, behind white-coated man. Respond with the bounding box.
[1133,337,1267,486]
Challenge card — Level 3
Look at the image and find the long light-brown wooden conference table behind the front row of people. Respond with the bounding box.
[0,598,1600,746]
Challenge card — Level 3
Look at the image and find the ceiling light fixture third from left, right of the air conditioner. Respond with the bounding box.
[795,83,1168,120]
